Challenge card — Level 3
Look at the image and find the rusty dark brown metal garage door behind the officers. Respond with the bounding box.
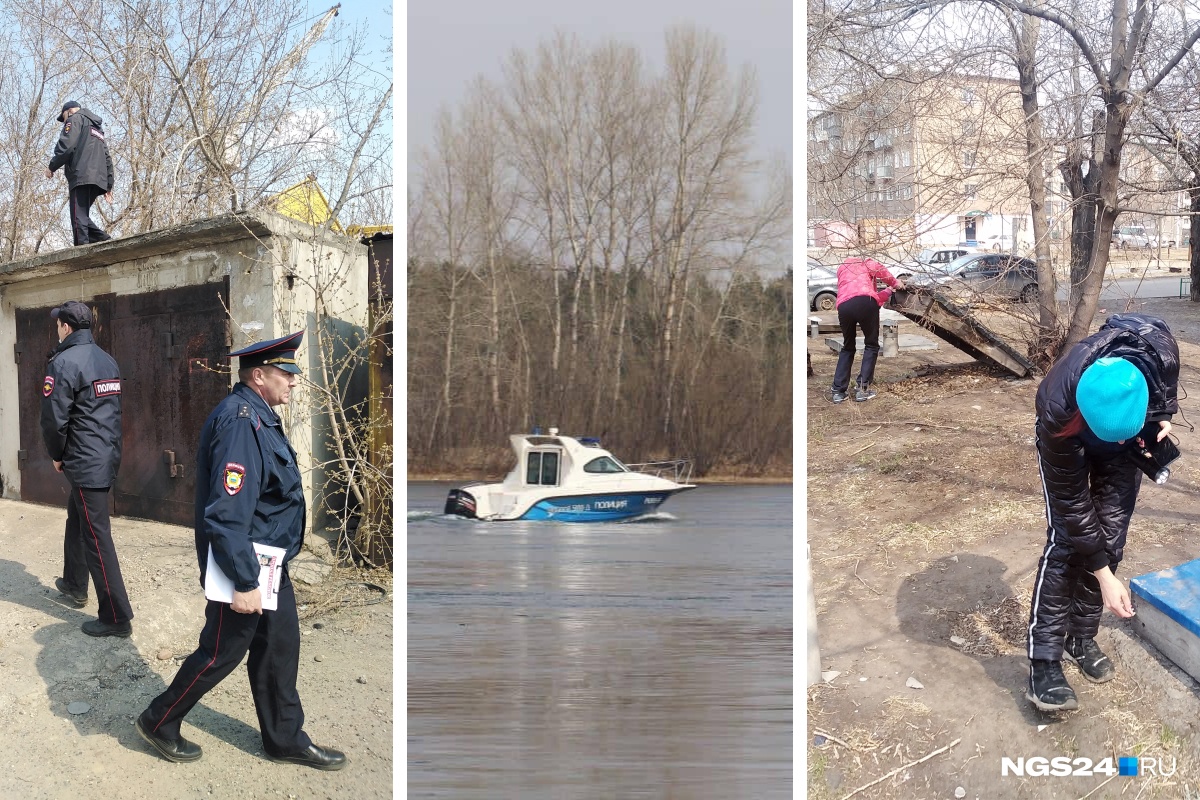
[17,278,229,525]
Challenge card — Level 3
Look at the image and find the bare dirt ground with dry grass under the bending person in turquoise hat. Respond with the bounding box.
[808,300,1200,799]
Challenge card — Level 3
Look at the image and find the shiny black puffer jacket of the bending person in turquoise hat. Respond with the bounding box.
[1036,314,1180,571]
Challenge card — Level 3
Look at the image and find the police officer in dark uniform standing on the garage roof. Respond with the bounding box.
[46,100,113,246]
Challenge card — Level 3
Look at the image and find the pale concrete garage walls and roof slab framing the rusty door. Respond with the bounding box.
[0,212,367,532]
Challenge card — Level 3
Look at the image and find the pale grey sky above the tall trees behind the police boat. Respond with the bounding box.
[408,0,792,169]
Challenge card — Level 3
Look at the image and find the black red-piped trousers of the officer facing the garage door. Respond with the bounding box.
[62,486,133,622]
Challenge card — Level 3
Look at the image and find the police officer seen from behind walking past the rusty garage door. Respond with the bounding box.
[42,300,133,637]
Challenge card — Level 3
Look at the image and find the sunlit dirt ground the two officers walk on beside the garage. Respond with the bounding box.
[0,500,392,800]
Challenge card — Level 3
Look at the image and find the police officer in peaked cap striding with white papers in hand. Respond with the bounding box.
[137,331,346,770]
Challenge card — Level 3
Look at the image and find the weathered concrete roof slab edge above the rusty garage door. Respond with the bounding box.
[0,212,274,285]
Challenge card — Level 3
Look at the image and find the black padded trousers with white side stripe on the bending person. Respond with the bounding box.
[1027,453,1141,661]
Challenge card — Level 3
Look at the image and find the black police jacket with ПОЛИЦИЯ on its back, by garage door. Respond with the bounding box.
[42,329,121,489]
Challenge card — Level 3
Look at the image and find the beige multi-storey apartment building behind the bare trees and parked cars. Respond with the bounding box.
[808,73,1032,251]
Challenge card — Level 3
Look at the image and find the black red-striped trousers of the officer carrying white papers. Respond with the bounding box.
[146,572,312,756]
